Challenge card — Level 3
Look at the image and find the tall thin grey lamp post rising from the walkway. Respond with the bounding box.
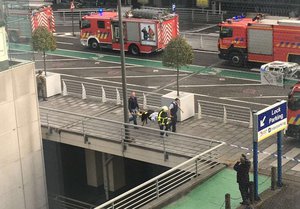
[118,0,129,123]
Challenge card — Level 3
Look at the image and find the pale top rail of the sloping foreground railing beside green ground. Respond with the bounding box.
[94,143,224,209]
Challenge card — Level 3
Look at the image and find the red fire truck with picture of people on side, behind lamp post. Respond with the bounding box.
[80,9,179,55]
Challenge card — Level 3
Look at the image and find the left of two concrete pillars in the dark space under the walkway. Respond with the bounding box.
[85,149,103,187]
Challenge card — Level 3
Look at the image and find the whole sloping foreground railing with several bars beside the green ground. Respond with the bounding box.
[95,144,223,209]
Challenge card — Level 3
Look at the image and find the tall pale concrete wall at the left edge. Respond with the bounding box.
[0,63,48,209]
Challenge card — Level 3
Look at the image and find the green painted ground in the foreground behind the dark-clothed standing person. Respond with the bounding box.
[163,169,271,209]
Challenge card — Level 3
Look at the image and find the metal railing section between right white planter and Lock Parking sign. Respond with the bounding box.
[198,100,253,128]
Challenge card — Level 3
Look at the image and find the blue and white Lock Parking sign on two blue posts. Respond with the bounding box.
[253,101,287,200]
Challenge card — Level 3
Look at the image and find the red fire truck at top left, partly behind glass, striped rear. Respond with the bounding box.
[7,4,55,42]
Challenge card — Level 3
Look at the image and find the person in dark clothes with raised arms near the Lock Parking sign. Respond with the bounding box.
[233,154,251,205]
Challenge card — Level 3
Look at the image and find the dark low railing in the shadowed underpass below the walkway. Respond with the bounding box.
[48,195,96,209]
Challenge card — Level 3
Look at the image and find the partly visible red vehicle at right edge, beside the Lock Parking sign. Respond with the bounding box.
[286,82,300,139]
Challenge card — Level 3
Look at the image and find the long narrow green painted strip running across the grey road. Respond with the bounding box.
[10,44,296,84]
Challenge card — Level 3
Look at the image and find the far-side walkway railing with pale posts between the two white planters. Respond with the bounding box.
[62,79,162,109]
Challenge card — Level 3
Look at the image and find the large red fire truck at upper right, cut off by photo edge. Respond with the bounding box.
[218,14,300,66]
